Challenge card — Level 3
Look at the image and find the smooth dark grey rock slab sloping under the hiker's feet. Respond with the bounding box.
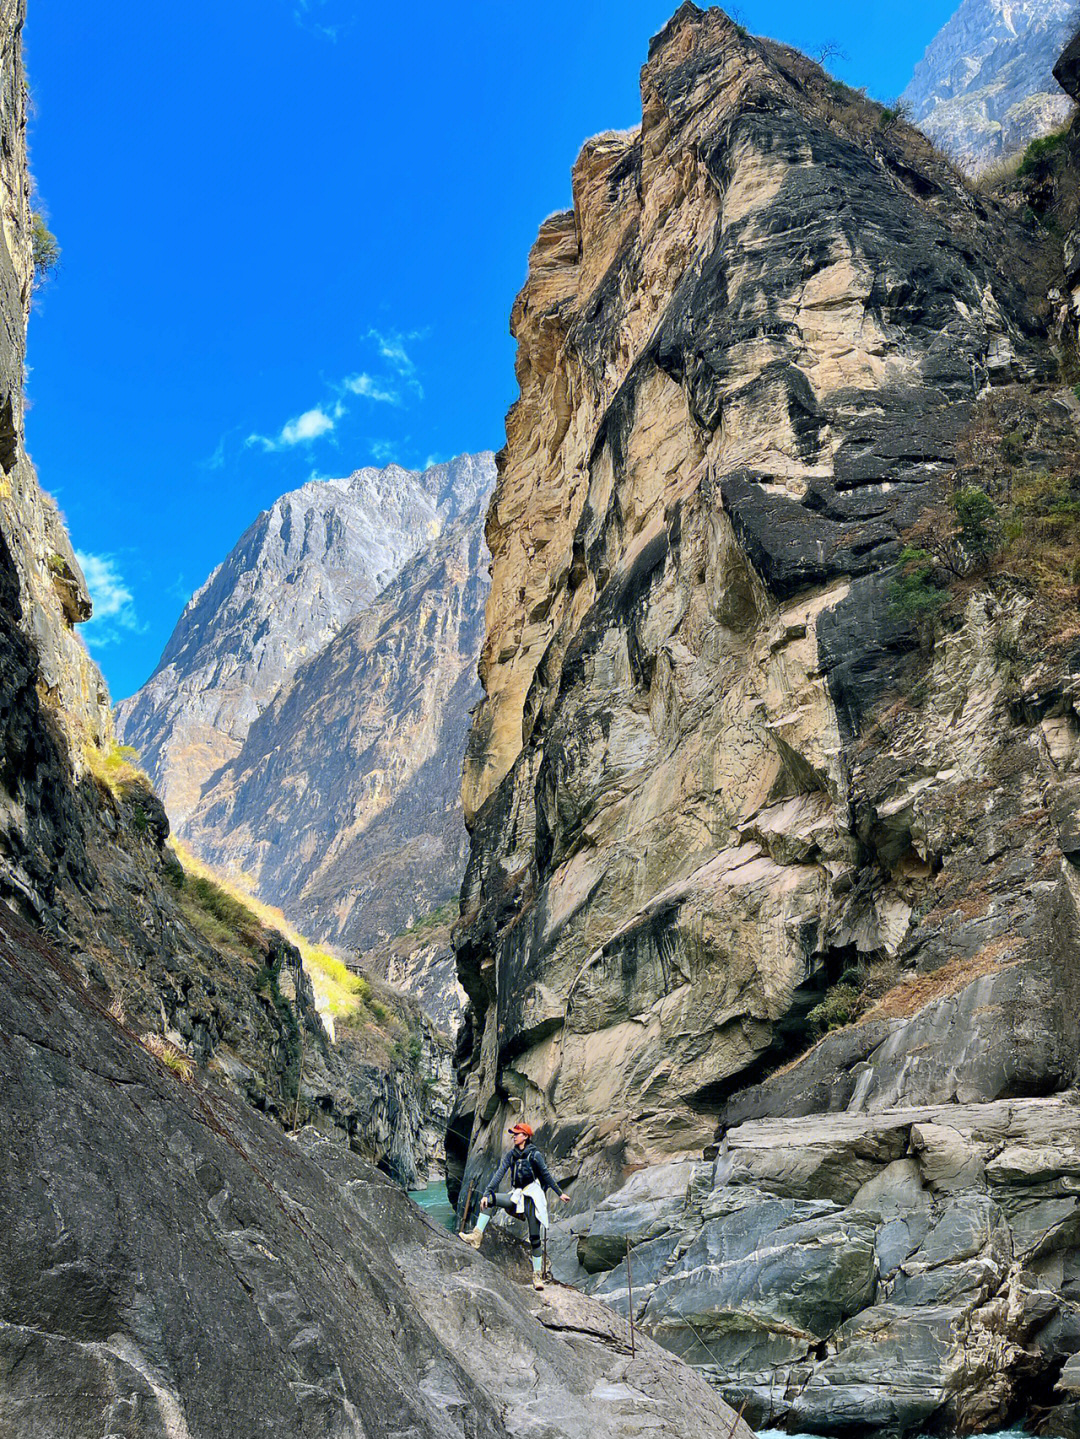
[0,915,751,1439]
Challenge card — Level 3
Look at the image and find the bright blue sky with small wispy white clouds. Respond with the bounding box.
[26,0,955,698]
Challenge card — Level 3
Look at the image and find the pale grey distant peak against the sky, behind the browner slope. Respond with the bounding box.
[116,453,493,833]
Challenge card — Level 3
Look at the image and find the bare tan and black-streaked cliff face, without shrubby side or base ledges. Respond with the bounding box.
[449,4,1071,1204]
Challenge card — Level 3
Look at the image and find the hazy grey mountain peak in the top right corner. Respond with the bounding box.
[902,0,1079,174]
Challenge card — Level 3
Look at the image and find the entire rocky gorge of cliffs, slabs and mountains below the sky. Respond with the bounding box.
[0,0,1080,1439]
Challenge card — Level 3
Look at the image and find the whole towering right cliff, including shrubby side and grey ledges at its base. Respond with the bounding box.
[447,4,1080,1433]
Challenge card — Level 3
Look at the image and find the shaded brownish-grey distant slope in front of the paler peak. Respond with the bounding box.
[186,492,488,955]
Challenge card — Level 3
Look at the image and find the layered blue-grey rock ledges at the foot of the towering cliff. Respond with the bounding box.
[552,1094,1080,1433]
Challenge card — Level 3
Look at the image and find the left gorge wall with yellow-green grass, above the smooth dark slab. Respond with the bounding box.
[0,4,440,1207]
